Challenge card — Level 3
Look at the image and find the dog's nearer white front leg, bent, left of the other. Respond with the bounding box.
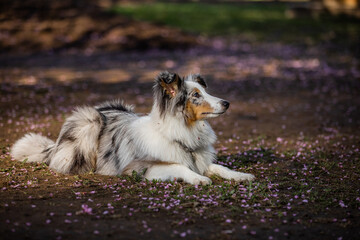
[145,164,211,185]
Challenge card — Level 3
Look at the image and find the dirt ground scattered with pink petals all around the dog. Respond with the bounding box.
[0,0,360,239]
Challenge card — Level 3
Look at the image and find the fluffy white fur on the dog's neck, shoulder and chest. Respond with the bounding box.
[130,112,216,174]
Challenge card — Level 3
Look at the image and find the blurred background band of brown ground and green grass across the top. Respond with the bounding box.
[0,0,360,56]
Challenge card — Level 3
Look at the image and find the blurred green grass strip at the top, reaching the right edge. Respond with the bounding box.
[109,3,360,43]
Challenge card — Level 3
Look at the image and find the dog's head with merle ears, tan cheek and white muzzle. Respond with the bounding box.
[154,72,230,125]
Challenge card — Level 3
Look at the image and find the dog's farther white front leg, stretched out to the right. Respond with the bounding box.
[205,164,255,182]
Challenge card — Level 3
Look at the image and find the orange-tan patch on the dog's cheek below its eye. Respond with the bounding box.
[185,99,214,126]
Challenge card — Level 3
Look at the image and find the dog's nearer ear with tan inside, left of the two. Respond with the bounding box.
[156,71,183,97]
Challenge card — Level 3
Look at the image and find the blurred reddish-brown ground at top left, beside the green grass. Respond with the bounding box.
[0,0,197,54]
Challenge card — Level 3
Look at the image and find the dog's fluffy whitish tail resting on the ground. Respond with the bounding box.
[11,133,54,162]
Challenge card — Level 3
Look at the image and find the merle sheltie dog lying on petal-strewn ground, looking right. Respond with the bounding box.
[11,72,255,185]
